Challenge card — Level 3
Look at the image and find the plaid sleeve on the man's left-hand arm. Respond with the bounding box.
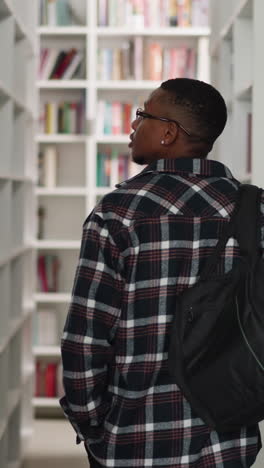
[60,213,123,442]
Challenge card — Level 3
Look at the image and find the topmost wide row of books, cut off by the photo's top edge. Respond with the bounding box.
[98,0,209,27]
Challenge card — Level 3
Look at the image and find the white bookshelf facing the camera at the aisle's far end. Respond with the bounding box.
[34,0,210,414]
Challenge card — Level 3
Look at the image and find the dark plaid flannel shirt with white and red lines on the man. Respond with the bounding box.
[61,158,264,468]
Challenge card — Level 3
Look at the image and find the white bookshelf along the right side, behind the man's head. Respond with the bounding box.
[210,0,264,187]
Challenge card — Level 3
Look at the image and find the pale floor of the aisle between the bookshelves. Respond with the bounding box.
[22,419,264,468]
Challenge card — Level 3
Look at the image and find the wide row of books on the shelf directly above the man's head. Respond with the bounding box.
[98,41,197,81]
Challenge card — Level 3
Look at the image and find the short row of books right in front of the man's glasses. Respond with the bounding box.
[96,100,137,135]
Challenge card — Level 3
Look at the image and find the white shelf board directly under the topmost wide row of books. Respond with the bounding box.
[96,26,210,37]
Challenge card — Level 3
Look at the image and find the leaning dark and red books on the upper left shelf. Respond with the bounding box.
[38,48,85,80]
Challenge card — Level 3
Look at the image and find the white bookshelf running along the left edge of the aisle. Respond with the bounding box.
[0,0,37,468]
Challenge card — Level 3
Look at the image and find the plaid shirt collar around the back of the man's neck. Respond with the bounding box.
[141,158,234,179]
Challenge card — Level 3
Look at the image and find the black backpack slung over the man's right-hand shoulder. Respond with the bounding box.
[168,185,264,431]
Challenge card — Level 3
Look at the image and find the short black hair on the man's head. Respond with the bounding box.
[161,78,227,144]
